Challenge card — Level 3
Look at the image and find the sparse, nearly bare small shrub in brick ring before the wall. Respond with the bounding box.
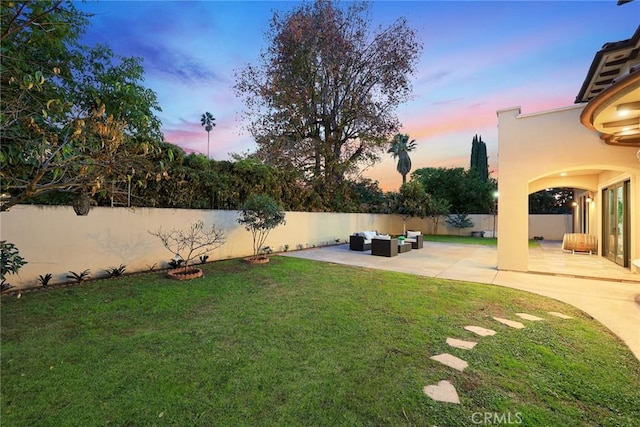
[149,221,227,272]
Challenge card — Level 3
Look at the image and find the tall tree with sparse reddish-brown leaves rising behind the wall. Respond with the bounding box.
[235,0,421,208]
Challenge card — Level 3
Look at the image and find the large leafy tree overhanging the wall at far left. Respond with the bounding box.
[0,1,162,211]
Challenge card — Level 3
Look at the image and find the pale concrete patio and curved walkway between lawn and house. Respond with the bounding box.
[281,241,640,360]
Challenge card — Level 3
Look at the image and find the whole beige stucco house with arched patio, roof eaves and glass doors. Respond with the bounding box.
[497,26,640,271]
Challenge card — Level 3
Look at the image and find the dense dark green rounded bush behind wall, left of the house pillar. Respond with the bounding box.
[411,168,497,213]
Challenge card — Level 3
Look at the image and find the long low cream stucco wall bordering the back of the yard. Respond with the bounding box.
[0,205,571,288]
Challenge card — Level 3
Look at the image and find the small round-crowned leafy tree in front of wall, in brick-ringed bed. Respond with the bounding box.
[237,194,285,259]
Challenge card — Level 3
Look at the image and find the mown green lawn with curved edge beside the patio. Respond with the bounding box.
[0,256,640,427]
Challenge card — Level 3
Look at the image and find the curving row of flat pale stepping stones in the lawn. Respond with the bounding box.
[422,311,573,405]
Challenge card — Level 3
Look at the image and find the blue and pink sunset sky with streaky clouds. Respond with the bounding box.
[76,0,640,191]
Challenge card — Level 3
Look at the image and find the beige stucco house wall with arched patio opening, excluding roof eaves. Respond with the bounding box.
[497,105,640,271]
